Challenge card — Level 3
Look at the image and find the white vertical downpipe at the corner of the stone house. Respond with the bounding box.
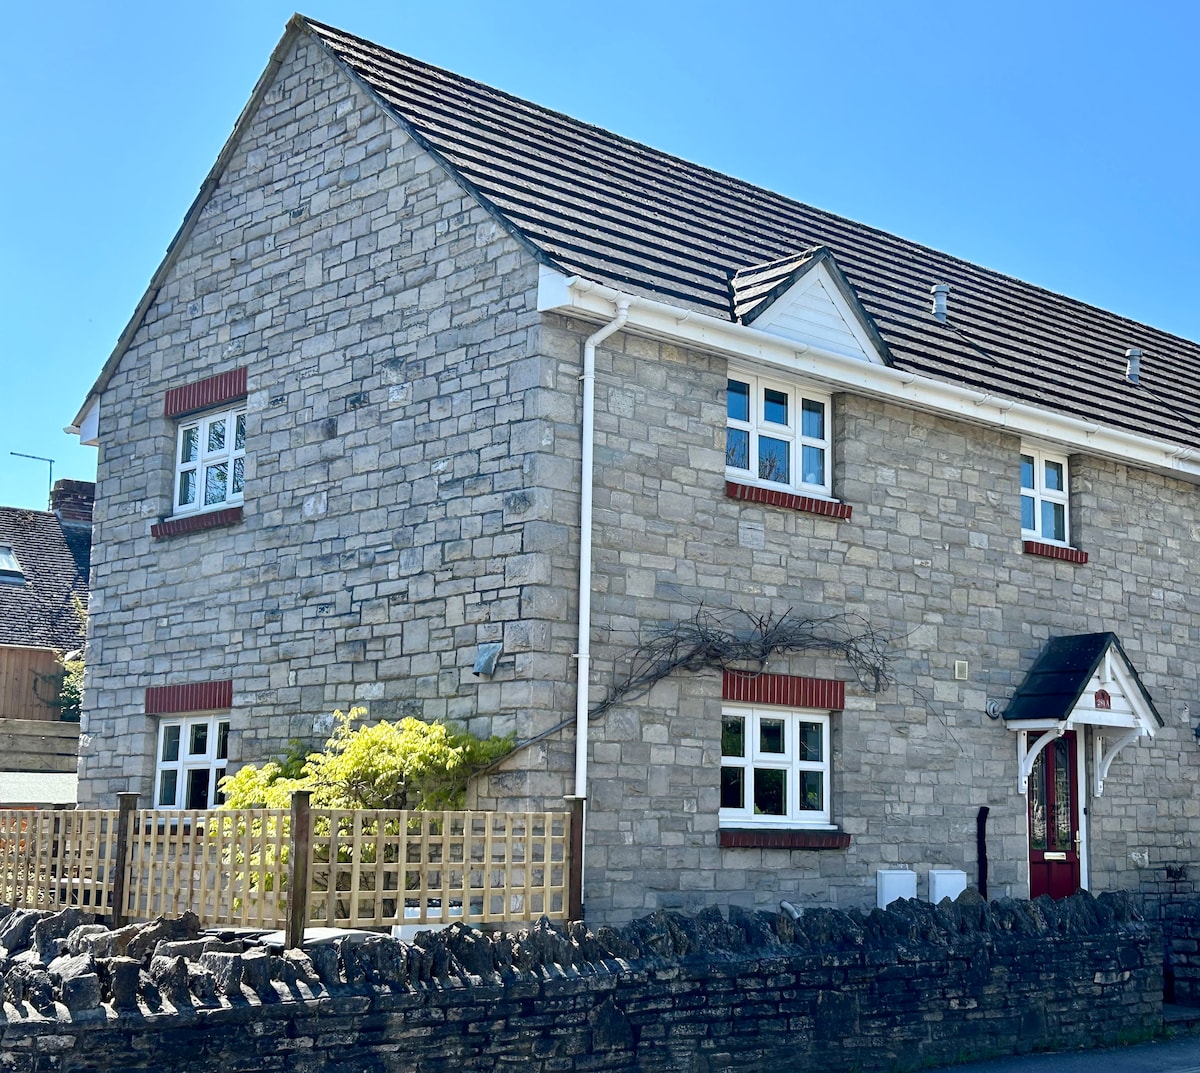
[574,296,630,801]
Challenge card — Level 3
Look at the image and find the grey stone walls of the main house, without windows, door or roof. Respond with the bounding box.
[79,18,1200,923]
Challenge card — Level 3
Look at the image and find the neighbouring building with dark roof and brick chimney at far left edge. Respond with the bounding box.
[0,480,95,807]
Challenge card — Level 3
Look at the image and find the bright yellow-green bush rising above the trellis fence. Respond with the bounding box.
[221,708,514,809]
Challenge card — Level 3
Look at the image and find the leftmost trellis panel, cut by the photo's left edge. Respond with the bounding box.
[0,809,116,912]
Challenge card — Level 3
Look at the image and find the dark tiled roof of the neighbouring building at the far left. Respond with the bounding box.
[0,506,91,652]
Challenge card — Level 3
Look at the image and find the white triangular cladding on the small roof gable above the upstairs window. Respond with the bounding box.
[734,263,886,365]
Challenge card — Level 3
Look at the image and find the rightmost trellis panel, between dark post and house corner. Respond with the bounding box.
[306,809,571,928]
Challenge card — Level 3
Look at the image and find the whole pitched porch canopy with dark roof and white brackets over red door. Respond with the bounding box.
[1004,633,1164,797]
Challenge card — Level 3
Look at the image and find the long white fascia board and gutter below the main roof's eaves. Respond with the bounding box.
[538,265,1200,484]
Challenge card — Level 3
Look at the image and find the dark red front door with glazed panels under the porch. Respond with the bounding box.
[1028,731,1079,898]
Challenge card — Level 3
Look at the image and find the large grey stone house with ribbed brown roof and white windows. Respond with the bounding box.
[76,17,1200,922]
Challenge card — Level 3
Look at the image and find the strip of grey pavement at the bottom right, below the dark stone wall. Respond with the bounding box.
[923,1006,1200,1073]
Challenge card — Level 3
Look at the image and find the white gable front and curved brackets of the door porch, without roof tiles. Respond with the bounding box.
[1009,645,1159,797]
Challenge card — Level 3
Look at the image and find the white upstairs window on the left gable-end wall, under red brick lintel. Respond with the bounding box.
[174,407,246,515]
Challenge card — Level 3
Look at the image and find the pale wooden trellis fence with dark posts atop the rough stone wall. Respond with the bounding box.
[0,793,582,946]
